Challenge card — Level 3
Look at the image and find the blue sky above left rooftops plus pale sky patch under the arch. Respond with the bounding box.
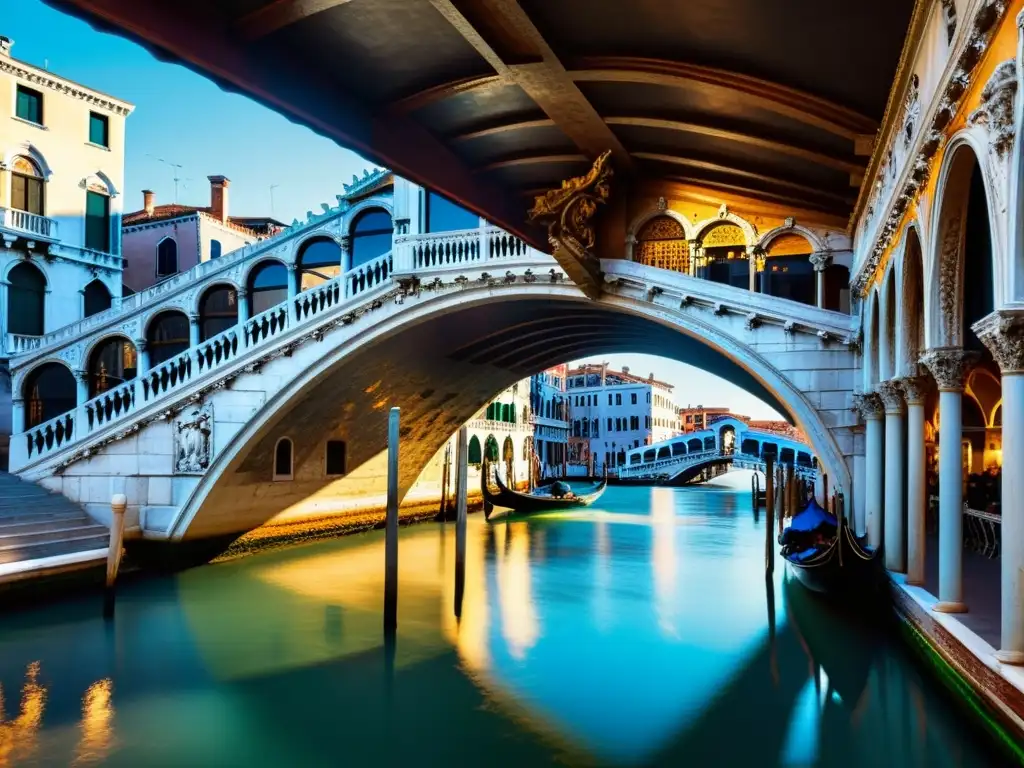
[6,0,779,419]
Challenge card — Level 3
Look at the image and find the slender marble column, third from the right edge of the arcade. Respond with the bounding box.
[900,376,929,586]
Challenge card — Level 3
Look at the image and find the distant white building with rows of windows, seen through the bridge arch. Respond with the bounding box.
[565,362,680,474]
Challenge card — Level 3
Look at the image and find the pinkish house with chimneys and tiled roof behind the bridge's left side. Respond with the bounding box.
[121,176,285,293]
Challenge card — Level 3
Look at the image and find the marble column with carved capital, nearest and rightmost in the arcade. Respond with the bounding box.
[973,307,1024,665]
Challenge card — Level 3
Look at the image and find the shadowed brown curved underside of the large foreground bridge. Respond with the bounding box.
[192,300,788,539]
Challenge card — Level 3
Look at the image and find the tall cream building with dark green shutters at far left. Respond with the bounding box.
[0,37,133,469]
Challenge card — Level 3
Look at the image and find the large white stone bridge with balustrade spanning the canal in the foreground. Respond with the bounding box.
[10,222,858,561]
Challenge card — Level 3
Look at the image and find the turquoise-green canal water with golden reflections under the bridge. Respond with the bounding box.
[0,486,997,768]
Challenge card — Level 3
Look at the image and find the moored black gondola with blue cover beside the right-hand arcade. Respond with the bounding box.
[779,500,884,604]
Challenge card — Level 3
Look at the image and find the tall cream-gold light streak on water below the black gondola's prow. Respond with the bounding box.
[498,522,540,659]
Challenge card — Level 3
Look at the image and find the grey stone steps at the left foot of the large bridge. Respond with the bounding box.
[0,472,110,584]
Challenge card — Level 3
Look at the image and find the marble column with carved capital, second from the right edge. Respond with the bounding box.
[921,347,970,613]
